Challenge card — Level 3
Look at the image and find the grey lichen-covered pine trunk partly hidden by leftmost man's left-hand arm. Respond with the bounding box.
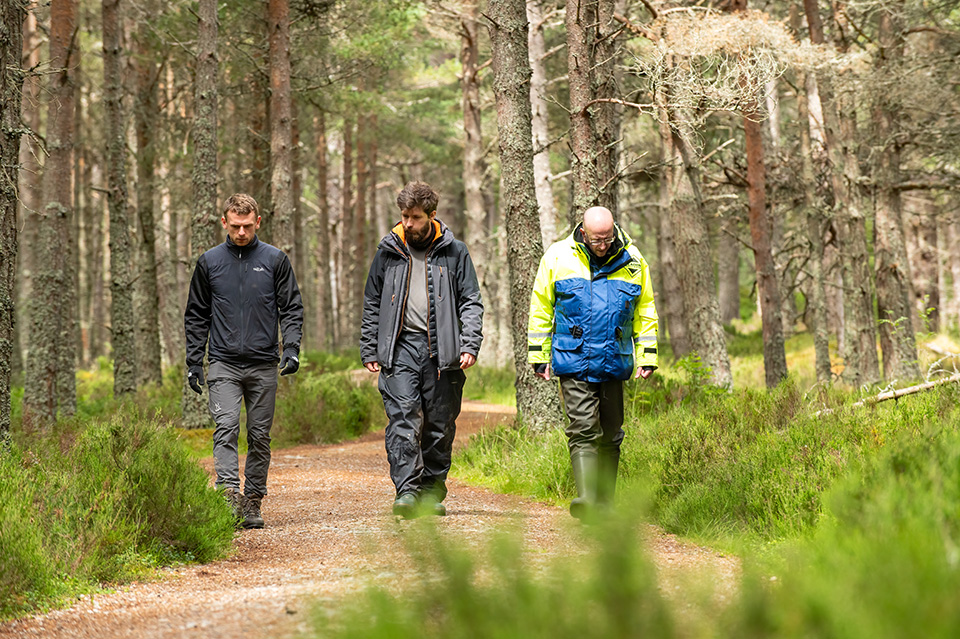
[182,0,220,428]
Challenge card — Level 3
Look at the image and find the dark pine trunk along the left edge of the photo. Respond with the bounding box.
[0,2,26,446]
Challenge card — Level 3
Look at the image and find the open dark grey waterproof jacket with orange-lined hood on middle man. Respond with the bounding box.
[360,220,483,370]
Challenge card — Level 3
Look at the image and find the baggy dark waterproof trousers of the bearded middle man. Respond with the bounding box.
[378,331,466,500]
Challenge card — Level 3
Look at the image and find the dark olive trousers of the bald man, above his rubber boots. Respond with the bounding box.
[560,377,623,455]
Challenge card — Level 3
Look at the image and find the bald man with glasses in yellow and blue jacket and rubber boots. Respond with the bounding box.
[527,206,657,521]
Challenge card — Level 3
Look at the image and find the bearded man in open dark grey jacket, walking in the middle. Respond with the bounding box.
[360,182,483,518]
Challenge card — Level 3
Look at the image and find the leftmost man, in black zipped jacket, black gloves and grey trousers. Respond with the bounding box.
[183,193,303,528]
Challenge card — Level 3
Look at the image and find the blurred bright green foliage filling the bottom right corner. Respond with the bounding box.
[728,412,960,639]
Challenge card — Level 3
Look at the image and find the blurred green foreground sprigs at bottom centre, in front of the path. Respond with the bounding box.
[316,523,675,639]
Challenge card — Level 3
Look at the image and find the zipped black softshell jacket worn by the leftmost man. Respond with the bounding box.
[183,237,303,368]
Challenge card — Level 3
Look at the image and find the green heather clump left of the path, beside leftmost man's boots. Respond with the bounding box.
[0,411,233,617]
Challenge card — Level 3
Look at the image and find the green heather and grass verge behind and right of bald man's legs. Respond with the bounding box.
[453,376,960,543]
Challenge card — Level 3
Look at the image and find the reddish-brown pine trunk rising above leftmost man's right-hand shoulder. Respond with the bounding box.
[267,0,293,254]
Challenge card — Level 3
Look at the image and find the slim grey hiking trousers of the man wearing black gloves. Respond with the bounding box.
[207,362,277,497]
